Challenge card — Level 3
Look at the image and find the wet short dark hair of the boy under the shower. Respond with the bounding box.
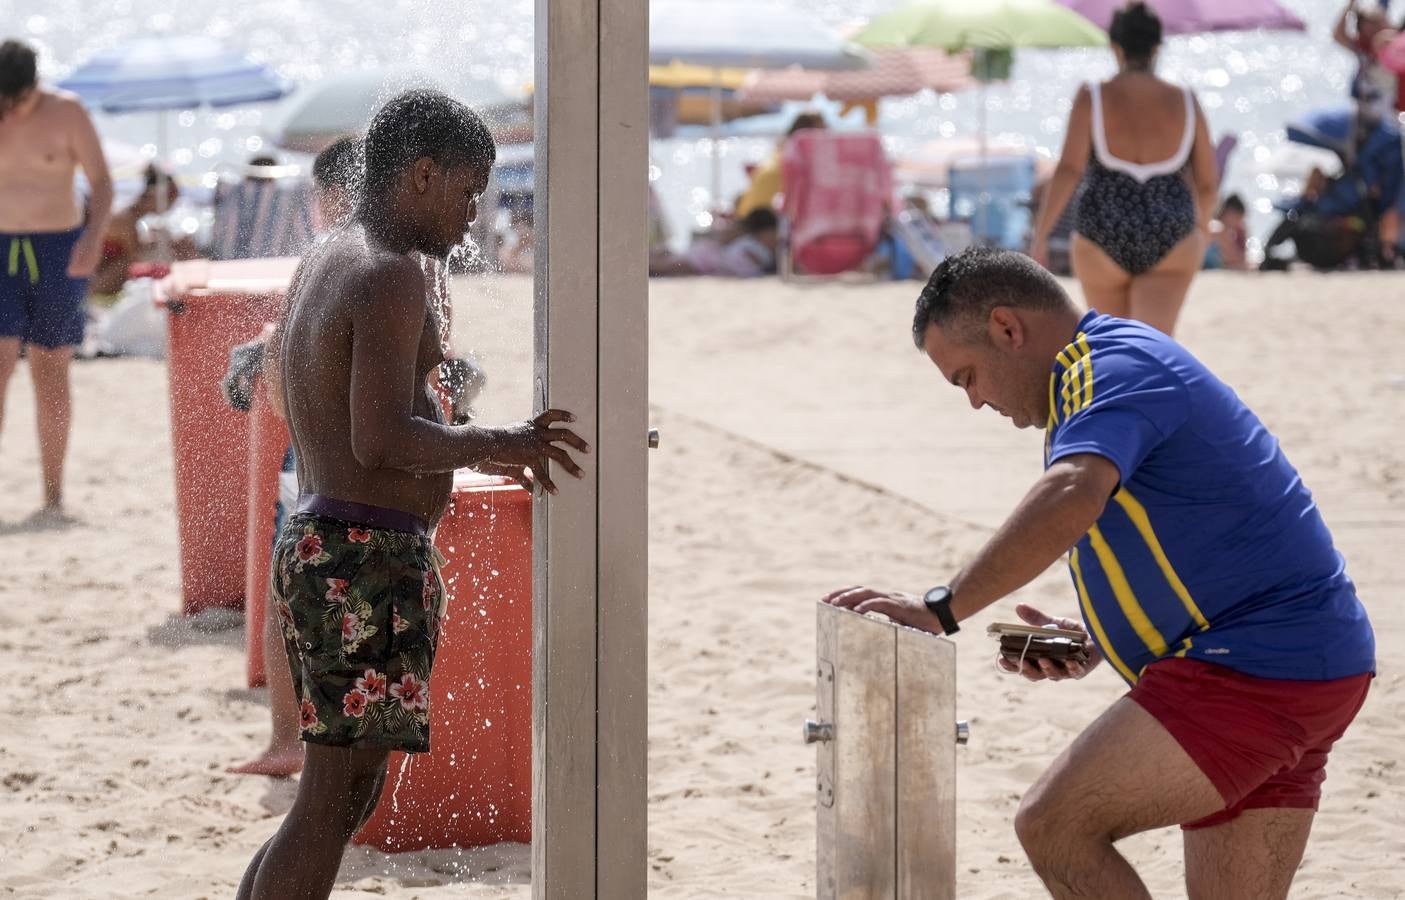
[362,88,497,197]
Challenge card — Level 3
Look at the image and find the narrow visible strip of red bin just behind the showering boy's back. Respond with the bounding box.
[244,378,291,688]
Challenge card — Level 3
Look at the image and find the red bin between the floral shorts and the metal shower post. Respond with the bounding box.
[353,475,532,852]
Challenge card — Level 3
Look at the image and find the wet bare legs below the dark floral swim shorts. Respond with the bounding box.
[236,744,389,900]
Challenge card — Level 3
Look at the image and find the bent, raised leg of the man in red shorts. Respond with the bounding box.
[1014,698,1225,900]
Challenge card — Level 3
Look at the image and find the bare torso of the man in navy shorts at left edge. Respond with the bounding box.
[0,88,83,234]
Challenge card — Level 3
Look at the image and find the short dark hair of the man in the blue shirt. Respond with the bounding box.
[912,247,1069,350]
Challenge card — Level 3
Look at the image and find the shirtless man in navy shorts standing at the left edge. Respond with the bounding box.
[0,41,112,524]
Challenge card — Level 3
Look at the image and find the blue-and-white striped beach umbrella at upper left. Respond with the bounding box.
[59,35,292,112]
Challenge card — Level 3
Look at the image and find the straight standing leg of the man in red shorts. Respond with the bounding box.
[1186,809,1315,900]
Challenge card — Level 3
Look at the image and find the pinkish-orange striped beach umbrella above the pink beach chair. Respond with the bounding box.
[740,46,975,120]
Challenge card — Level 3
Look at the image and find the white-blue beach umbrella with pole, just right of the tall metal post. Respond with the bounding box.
[649,0,868,212]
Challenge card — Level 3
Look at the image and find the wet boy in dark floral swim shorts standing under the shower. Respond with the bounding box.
[237,90,587,900]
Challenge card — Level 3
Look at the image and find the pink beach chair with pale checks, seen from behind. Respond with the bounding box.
[781,129,892,277]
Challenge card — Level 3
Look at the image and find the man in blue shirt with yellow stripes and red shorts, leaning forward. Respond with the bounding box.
[825,249,1375,899]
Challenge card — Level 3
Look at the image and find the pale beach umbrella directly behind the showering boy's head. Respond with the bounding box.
[264,67,524,153]
